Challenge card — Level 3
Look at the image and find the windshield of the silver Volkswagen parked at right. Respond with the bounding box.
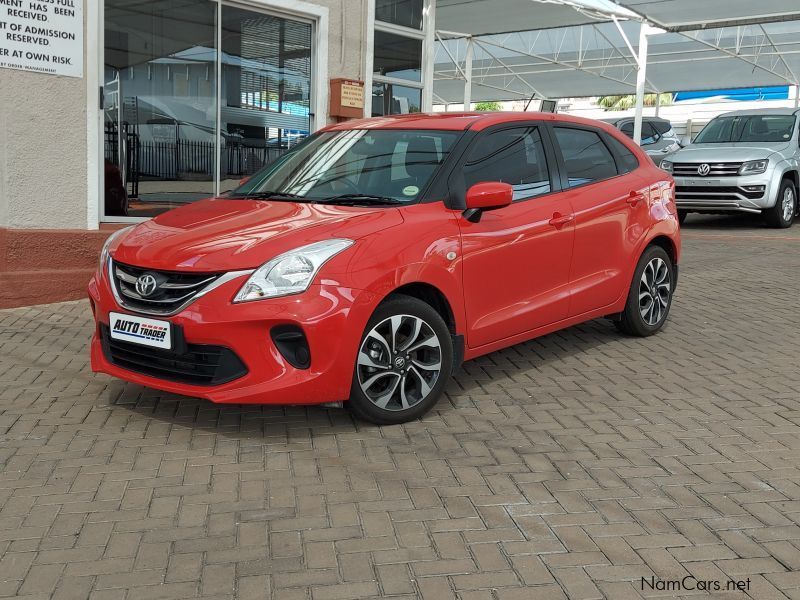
[694,115,795,144]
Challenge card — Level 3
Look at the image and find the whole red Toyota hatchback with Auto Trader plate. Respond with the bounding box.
[89,113,680,423]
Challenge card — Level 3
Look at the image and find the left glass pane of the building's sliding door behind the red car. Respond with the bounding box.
[103,0,217,218]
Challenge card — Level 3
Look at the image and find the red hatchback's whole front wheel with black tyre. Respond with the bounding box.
[346,294,453,425]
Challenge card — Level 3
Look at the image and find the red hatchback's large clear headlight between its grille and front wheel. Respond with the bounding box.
[233,239,353,302]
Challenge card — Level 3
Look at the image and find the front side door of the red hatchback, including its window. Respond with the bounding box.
[455,125,574,348]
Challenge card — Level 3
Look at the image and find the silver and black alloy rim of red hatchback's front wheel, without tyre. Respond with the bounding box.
[356,315,442,411]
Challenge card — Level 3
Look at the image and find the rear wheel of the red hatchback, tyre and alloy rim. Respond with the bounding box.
[615,246,675,337]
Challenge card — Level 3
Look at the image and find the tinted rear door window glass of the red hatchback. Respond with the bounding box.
[555,127,617,187]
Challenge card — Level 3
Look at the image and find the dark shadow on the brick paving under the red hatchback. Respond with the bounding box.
[101,319,630,439]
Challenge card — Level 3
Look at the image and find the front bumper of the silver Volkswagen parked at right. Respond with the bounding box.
[675,171,775,213]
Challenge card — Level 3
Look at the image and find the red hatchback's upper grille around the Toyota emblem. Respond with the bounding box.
[111,261,221,315]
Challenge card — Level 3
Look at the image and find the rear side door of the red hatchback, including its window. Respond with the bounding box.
[553,123,649,316]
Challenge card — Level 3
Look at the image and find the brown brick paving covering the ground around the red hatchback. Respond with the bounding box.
[0,217,800,600]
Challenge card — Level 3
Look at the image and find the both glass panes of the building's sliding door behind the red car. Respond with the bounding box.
[102,0,313,220]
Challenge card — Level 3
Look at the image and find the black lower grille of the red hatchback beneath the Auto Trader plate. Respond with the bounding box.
[100,325,247,386]
